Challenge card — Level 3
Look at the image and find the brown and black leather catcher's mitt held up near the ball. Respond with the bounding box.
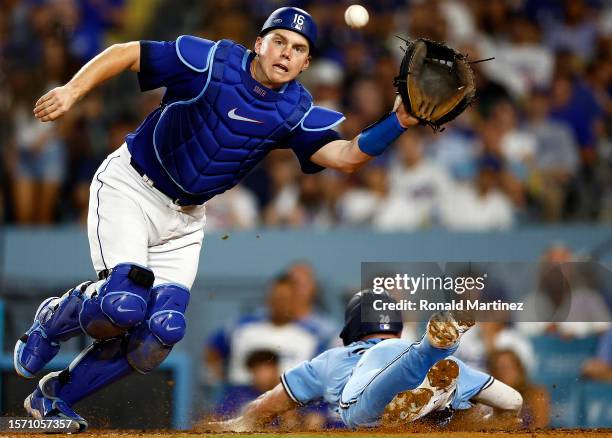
[394,38,476,132]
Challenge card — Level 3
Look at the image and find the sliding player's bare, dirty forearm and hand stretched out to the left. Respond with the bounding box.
[209,384,297,432]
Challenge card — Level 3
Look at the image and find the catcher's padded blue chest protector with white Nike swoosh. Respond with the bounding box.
[153,40,312,200]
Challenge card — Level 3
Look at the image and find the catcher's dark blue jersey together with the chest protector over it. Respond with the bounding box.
[126,37,344,204]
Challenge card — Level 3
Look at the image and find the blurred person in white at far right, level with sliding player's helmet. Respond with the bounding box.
[517,243,611,338]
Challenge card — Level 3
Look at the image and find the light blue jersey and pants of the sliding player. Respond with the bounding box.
[281,337,493,427]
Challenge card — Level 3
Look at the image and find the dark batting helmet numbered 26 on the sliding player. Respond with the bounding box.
[340,289,404,345]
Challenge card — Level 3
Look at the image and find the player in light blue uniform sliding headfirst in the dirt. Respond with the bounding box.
[213,291,523,432]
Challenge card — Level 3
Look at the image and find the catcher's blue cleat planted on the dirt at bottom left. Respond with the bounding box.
[23,373,88,433]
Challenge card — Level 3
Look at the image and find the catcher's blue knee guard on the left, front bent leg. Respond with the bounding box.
[79,263,155,339]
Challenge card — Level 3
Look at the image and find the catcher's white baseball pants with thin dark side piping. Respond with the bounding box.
[87,143,206,289]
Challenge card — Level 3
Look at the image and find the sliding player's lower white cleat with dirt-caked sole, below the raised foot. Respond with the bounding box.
[382,359,459,427]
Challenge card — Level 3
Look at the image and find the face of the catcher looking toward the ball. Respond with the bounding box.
[253,29,310,88]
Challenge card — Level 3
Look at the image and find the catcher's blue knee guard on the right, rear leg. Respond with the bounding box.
[127,284,189,373]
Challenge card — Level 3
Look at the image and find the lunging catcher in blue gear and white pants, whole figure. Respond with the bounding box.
[14,7,476,431]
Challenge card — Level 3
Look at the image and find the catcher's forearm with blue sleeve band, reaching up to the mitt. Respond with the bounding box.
[310,101,418,173]
